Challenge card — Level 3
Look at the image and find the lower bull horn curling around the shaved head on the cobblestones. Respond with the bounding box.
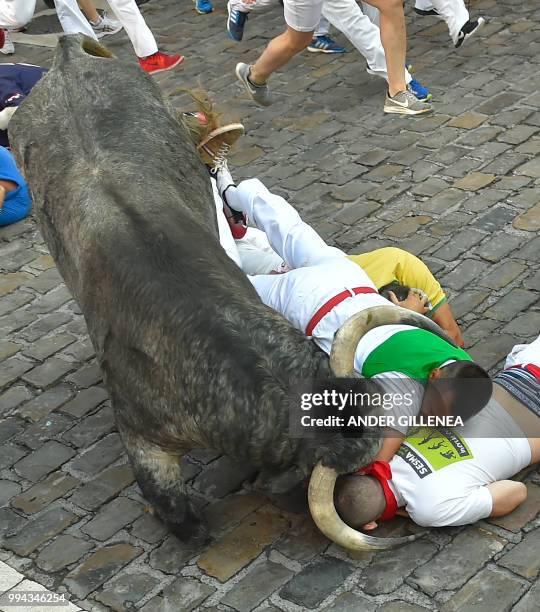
[308,463,425,550]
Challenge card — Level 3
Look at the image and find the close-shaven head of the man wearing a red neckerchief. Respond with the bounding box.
[334,474,386,529]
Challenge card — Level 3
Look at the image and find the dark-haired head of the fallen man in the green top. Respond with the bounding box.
[422,361,493,421]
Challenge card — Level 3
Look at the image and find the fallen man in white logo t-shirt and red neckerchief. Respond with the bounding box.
[336,336,540,530]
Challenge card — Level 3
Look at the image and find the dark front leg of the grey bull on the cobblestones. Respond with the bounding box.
[120,427,207,544]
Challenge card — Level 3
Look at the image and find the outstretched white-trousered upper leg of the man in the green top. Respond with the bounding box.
[226,179,345,268]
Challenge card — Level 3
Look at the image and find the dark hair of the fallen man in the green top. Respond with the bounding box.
[431,361,493,421]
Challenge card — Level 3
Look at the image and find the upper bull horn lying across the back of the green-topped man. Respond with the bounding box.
[330,305,456,378]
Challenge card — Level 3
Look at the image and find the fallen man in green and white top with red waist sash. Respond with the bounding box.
[208,160,491,460]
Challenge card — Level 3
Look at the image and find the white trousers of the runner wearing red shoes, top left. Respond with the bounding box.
[54,0,158,57]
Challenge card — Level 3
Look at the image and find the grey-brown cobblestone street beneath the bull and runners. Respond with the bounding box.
[0,0,540,612]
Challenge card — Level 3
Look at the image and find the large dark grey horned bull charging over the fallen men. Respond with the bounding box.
[10,37,442,549]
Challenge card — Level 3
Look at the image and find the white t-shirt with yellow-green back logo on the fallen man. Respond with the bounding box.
[390,399,531,527]
